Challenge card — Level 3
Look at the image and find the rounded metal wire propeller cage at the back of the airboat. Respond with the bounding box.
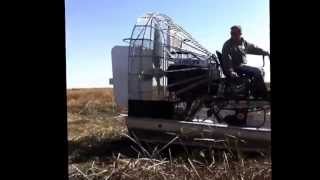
[124,13,216,100]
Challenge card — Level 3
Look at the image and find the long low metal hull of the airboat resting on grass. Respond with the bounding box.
[127,117,271,151]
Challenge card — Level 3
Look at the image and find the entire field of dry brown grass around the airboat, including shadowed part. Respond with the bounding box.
[67,88,271,180]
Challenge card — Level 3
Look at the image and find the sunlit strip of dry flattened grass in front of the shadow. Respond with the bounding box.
[69,155,271,180]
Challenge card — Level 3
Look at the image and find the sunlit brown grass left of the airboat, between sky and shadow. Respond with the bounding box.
[67,88,126,142]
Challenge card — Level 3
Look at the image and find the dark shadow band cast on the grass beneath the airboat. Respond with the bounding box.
[68,134,268,164]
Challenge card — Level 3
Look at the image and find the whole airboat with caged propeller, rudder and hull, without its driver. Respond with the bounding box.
[112,13,271,151]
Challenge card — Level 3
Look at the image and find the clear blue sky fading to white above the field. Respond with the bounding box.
[65,0,270,88]
